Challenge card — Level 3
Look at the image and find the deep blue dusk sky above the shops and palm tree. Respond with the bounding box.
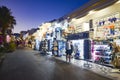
[0,0,90,32]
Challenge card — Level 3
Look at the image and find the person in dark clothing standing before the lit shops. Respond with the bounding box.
[66,40,73,62]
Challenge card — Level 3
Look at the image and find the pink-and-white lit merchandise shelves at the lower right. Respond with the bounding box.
[91,41,111,64]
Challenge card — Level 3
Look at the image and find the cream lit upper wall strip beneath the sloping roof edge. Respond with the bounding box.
[71,3,120,38]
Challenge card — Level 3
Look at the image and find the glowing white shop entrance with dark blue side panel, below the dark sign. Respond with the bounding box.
[72,39,91,60]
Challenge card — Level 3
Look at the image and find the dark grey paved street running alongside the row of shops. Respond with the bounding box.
[0,49,111,80]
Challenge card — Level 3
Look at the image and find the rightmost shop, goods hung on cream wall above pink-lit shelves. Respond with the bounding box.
[91,12,120,64]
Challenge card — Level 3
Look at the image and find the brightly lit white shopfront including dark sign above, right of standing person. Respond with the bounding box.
[67,32,91,60]
